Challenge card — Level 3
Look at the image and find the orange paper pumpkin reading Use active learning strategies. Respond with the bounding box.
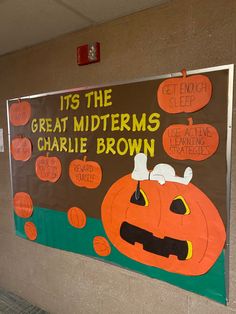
[162,118,219,161]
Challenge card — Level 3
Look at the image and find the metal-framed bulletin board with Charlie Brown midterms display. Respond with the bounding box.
[7,65,233,304]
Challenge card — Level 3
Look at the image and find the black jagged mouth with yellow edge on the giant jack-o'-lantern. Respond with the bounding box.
[120,221,192,260]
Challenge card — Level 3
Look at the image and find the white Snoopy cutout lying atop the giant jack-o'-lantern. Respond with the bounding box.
[131,153,193,185]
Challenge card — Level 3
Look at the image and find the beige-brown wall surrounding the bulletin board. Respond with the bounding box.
[0,0,236,314]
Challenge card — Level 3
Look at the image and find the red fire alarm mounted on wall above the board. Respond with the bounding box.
[77,42,100,65]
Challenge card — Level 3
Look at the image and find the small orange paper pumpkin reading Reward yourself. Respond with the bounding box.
[69,156,102,189]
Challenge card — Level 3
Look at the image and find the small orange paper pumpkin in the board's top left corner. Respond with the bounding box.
[9,100,31,126]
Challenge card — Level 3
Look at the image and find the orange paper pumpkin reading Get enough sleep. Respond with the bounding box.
[157,69,212,113]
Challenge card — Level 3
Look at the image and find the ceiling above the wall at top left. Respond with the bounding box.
[0,0,167,55]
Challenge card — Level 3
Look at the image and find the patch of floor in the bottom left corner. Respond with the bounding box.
[0,289,48,314]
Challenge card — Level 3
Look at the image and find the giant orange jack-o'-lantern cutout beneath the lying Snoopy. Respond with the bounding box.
[102,175,226,275]
